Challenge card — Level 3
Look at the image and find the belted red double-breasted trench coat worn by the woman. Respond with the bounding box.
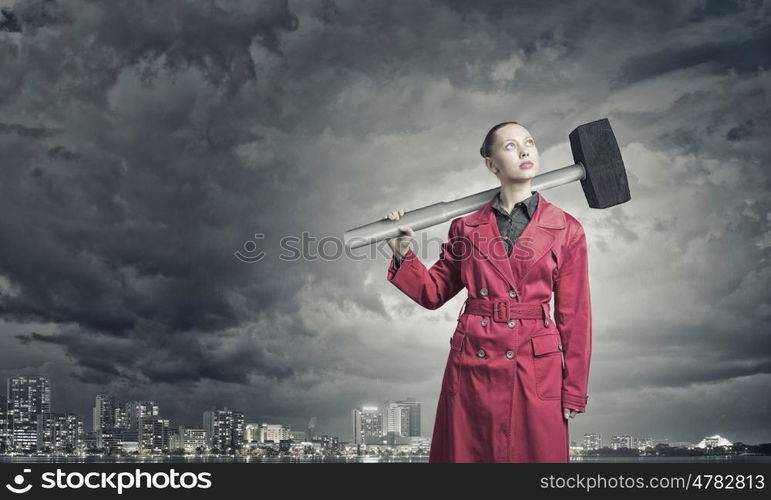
[387,192,592,462]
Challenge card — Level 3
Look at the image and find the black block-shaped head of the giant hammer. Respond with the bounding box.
[570,118,632,208]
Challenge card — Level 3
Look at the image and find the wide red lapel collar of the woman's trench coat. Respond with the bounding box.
[464,192,566,293]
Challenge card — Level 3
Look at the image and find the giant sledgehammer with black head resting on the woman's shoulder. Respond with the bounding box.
[343,118,632,249]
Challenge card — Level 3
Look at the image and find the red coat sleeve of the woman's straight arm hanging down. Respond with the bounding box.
[554,223,592,412]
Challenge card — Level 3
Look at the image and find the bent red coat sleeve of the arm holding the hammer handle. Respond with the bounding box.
[387,219,464,309]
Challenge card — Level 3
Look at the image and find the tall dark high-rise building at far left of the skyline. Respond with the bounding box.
[6,376,51,452]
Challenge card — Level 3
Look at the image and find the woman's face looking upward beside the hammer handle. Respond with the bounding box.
[485,123,540,184]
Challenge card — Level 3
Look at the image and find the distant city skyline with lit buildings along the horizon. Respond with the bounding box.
[0,376,768,452]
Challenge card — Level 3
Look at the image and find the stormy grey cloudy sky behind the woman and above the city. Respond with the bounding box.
[0,0,771,443]
